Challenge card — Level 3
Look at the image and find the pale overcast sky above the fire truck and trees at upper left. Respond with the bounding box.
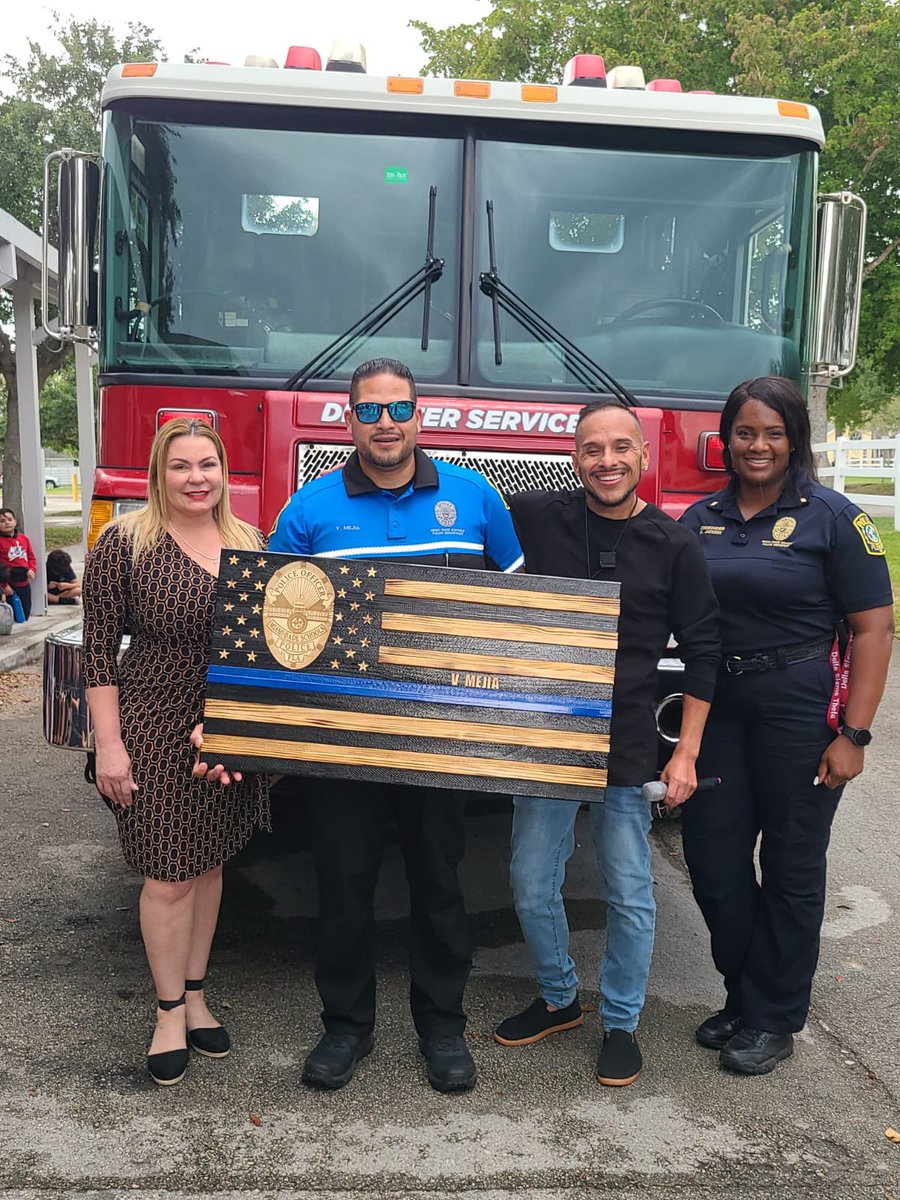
[0,0,491,74]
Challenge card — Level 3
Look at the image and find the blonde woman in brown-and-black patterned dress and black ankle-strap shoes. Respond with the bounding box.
[84,420,269,1084]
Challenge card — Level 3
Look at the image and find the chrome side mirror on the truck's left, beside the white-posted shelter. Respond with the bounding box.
[41,150,100,342]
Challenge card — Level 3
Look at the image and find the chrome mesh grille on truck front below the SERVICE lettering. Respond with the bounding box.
[296,443,576,496]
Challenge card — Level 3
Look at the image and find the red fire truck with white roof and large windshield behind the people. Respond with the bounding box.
[40,48,864,748]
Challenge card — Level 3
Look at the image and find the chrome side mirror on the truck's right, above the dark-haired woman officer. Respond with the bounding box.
[810,192,865,383]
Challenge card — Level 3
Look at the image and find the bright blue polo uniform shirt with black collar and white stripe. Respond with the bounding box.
[269,449,523,571]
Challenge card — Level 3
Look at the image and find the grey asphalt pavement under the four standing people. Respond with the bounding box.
[0,653,900,1200]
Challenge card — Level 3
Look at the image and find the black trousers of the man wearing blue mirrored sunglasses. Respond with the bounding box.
[310,780,472,1037]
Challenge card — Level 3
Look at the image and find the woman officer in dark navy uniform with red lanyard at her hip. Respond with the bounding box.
[682,376,894,1075]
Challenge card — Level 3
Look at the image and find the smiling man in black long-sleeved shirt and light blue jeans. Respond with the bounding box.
[494,400,719,1086]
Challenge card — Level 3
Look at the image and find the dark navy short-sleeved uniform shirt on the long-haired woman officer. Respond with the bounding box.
[682,480,893,655]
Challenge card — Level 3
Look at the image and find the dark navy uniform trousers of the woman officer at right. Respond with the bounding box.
[682,659,842,1033]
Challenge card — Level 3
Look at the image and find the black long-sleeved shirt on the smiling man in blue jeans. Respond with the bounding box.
[510,487,719,787]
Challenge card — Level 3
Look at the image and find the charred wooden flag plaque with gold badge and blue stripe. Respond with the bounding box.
[203,550,619,800]
